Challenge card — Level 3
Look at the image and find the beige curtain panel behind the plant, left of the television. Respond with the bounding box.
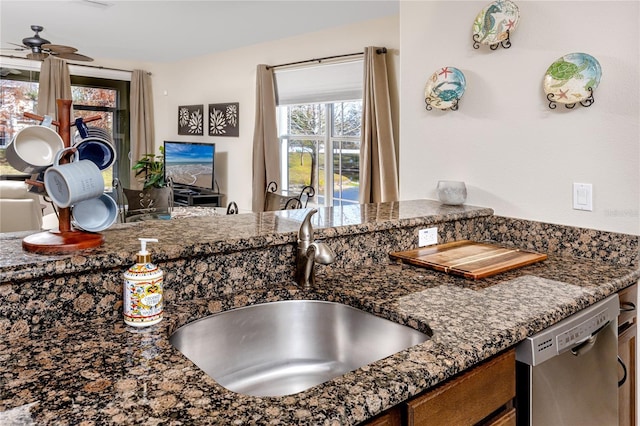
[130,70,155,189]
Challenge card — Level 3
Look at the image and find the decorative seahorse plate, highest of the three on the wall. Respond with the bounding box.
[473,0,520,45]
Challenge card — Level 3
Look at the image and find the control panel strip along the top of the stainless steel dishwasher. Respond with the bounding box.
[516,294,620,366]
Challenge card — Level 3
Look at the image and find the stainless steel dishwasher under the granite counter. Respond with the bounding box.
[516,294,620,426]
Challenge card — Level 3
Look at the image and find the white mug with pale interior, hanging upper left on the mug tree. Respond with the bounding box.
[6,126,64,174]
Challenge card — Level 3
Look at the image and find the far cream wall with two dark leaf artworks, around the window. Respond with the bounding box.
[150,16,399,211]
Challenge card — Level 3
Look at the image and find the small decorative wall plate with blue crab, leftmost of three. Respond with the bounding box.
[424,67,467,109]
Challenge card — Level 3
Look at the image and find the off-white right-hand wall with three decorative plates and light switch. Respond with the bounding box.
[400,0,640,235]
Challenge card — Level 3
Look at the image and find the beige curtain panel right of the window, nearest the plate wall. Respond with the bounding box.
[359,47,399,204]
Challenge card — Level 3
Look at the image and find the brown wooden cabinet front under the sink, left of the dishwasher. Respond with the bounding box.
[365,350,516,426]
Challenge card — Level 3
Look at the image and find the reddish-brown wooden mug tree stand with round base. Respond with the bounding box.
[22,99,104,254]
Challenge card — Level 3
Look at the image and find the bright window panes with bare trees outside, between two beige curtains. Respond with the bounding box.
[278,100,362,206]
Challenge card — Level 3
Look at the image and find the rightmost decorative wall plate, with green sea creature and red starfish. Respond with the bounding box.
[543,53,602,104]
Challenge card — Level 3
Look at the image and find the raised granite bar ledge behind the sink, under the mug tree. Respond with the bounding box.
[0,200,493,283]
